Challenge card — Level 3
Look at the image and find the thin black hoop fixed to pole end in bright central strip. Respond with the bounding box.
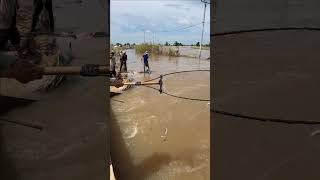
[144,69,210,102]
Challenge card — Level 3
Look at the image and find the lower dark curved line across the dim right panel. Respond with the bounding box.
[210,109,320,125]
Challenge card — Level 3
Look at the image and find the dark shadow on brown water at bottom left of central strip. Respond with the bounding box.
[110,111,172,180]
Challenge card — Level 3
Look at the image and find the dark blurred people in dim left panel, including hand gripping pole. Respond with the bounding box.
[0,0,54,83]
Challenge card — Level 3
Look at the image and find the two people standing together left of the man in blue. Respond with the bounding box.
[110,51,128,77]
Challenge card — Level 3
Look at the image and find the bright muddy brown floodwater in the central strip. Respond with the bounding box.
[111,50,210,180]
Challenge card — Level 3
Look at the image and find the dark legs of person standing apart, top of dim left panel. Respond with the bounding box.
[31,0,54,32]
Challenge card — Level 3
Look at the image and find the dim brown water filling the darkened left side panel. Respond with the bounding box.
[0,1,109,180]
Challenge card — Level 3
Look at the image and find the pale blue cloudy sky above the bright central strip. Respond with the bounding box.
[110,0,210,44]
